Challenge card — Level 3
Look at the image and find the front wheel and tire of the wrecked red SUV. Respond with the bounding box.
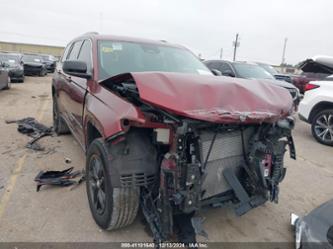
[86,138,139,230]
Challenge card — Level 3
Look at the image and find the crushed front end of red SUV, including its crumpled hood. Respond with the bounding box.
[103,73,296,243]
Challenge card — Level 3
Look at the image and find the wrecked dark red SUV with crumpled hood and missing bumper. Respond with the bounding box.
[52,33,295,242]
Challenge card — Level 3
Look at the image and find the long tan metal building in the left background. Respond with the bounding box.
[0,41,64,57]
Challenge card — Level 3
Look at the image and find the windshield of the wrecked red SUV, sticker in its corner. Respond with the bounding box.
[98,40,211,79]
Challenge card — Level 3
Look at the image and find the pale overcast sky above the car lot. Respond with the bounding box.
[0,0,333,64]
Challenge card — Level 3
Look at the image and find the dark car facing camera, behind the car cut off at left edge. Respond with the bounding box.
[0,52,24,82]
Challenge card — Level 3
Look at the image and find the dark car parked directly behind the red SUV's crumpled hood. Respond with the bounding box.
[204,60,301,107]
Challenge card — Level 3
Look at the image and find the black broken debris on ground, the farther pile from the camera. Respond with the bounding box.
[5,117,53,151]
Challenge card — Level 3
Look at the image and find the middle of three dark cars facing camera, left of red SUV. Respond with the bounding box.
[22,54,47,76]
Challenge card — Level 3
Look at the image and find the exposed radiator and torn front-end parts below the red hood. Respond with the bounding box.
[143,118,295,240]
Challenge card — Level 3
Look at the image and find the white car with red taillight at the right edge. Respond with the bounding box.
[298,76,333,146]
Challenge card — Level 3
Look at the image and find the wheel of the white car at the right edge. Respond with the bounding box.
[311,109,333,146]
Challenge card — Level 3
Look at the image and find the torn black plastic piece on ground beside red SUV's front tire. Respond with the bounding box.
[35,167,85,192]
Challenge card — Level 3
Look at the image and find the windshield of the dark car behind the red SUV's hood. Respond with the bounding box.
[234,63,274,80]
